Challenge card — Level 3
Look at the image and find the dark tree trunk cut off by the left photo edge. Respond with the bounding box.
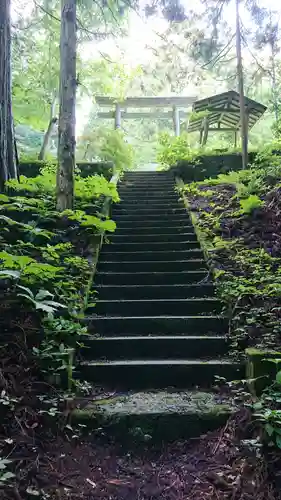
[0,0,17,189]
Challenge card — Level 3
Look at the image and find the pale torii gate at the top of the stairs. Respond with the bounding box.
[95,96,197,136]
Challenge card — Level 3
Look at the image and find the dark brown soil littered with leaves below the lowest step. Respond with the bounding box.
[12,411,281,500]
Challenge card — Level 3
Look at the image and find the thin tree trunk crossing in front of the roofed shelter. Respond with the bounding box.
[235,0,248,168]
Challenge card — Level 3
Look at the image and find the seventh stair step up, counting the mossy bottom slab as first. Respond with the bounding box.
[95,269,209,285]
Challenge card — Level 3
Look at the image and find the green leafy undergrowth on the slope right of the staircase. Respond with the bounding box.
[180,147,281,454]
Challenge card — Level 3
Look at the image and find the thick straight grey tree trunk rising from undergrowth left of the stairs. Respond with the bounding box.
[57,0,77,211]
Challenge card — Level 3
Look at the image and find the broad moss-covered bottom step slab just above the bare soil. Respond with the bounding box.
[72,390,233,446]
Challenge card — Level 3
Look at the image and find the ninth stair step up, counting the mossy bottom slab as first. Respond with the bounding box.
[100,248,204,262]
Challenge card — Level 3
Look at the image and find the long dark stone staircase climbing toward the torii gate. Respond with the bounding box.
[76,172,242,442]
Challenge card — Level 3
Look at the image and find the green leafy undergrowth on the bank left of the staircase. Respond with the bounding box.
[0,166,119,499]
